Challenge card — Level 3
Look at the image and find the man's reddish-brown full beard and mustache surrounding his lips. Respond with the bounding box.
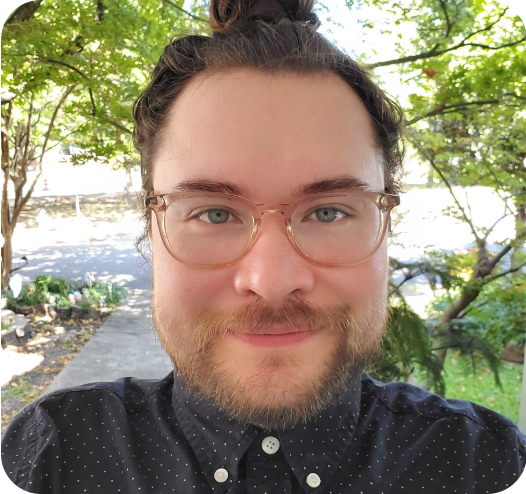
[152,294,389,430]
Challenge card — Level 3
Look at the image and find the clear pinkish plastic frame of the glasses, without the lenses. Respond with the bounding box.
[145,190,400,269]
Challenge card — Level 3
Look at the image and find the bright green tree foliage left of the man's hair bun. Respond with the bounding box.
[2,0,208,166]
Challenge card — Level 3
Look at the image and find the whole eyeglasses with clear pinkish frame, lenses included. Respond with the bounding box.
[145,190,400,268]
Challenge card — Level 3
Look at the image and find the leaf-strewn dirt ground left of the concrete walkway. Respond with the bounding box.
[2,315,107,435]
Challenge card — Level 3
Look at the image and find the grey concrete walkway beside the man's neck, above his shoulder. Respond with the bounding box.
[43,290,173,394]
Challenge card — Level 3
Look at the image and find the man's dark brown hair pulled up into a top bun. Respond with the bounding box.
[133,0,404,253]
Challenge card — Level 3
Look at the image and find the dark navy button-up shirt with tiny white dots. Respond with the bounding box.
[2,372,526,494]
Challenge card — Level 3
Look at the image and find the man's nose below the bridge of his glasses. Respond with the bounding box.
[234,211,315,303]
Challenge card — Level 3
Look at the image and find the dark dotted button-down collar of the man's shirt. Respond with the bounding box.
[172,369,361,494]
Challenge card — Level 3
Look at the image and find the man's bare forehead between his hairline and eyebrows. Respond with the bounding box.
[153,70,384,202]
